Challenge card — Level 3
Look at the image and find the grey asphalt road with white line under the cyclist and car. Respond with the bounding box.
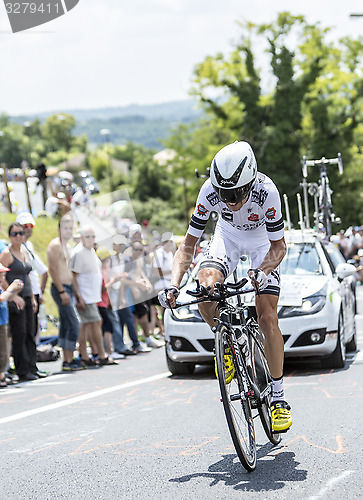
[0,287,363,500]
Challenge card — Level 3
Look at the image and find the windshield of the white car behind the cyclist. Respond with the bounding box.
[281,243,323,274]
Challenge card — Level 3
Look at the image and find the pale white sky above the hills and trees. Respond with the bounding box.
[0,0,363,115]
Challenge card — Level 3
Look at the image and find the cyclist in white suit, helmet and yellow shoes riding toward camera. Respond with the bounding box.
[159,141,292,432]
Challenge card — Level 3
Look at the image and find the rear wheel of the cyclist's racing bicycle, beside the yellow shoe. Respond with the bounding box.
[250,328,281,445]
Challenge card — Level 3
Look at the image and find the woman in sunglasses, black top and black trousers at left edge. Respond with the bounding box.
[0,222,38,382]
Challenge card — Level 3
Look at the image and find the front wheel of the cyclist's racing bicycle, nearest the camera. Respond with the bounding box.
[215,325,256,471]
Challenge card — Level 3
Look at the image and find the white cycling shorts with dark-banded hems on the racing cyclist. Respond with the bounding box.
[199,229,280,296]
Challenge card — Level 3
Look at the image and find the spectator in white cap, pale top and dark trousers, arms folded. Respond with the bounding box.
[107,235,147,356]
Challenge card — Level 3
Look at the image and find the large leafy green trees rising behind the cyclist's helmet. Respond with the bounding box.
[167,12,363,227]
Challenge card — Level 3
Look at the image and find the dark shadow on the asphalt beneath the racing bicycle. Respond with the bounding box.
[169,443,308,492]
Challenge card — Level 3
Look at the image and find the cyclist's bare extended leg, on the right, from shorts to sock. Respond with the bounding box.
[256,294,284,378]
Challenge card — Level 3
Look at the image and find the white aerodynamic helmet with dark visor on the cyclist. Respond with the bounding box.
[210,141,257,203]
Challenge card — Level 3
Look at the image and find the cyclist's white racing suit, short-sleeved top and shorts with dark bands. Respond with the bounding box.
[188,172,284,295]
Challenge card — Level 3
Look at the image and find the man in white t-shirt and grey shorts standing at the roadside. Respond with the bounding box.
[70,226,117,366]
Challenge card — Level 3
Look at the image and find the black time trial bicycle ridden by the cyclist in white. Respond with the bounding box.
[172,278,281,471]
